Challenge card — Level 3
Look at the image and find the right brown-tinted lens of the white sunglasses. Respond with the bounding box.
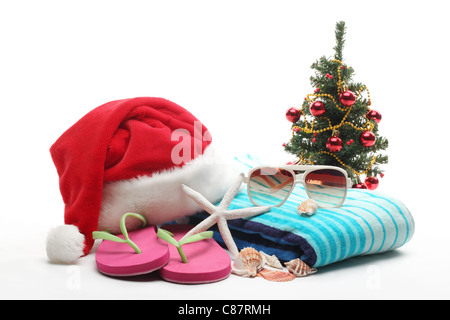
[305,169,347,208]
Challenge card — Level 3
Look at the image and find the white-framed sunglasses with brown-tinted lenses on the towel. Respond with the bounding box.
[244,165,352,208]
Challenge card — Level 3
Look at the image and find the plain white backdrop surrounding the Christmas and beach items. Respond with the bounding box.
[0,0,450,299]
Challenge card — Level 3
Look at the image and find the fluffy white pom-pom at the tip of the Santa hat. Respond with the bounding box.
[47,224,84,263]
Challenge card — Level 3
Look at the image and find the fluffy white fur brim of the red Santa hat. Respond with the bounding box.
[98,145,237,233]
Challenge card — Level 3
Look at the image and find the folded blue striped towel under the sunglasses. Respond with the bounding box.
[190,156,414,267]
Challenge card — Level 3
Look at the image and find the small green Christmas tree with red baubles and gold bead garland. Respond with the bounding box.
[285,21,388,190]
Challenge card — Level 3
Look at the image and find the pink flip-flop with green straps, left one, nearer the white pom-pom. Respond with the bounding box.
[92,213,169,277]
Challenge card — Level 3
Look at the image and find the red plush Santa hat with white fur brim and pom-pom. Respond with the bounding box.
[47,97,234,263]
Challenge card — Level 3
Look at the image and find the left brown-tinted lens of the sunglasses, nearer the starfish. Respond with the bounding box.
[248,167,294,206]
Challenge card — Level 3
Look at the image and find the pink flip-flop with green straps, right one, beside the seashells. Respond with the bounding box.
[157,224,231,284]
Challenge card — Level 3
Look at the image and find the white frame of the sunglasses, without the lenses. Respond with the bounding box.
[244,165,352,209]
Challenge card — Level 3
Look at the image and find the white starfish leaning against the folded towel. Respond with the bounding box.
[182,173,270,258]
